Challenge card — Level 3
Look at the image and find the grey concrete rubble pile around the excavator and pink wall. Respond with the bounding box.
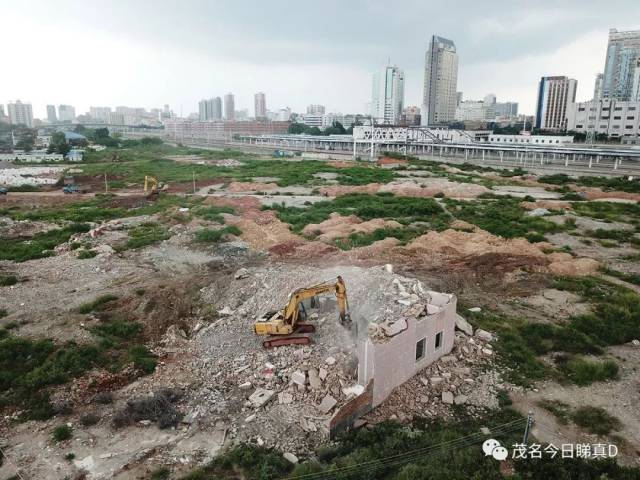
[159,265,497,453]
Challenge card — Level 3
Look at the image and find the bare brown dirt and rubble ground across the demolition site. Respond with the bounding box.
[0,161,640,479]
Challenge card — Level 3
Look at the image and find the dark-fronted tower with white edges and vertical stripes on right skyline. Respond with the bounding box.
[536,76,578,130]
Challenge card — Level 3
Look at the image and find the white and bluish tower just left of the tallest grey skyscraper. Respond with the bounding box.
[371,65,404,125]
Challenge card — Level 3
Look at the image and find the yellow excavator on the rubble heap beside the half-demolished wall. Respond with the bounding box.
[254,276,351,348]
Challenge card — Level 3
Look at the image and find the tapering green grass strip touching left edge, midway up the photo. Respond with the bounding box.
[0,223,89,262]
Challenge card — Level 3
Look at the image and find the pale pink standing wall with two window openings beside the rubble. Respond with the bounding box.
[358,292,457,407]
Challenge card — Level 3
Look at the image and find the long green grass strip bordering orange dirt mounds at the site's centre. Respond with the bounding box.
[271,194,450,233]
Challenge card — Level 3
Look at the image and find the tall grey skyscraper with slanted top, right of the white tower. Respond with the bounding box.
[421,35,458,125]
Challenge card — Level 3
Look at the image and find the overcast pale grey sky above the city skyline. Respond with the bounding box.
[0,0,640,117]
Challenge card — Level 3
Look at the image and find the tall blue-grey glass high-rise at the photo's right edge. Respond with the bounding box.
[602,28,640,100]
